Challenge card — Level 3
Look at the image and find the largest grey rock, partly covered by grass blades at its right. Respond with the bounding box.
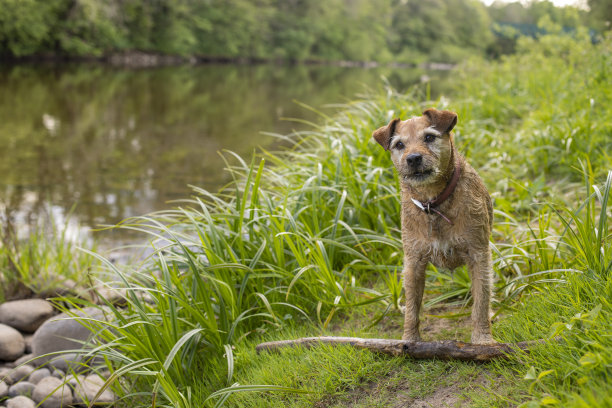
[32,307,104,363]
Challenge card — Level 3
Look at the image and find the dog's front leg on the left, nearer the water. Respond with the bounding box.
[402,257,427,341]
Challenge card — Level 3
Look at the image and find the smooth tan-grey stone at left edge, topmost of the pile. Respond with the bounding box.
[0,299,53,333]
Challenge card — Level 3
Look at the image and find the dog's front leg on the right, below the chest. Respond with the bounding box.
[468,247,496,344]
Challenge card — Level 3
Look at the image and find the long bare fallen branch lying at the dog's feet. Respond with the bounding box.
[255,337,546,361]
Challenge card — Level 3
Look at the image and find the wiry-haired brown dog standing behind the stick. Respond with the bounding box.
[372,109,495,344]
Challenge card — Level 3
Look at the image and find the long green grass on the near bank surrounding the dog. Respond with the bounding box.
[44,30,612,407]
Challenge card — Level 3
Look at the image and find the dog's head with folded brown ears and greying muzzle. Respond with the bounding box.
[372,108,457,187]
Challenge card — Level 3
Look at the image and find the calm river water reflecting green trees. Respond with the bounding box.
[0,65,443,244]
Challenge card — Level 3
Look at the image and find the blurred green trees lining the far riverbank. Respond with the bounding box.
[0,0,605,62]
